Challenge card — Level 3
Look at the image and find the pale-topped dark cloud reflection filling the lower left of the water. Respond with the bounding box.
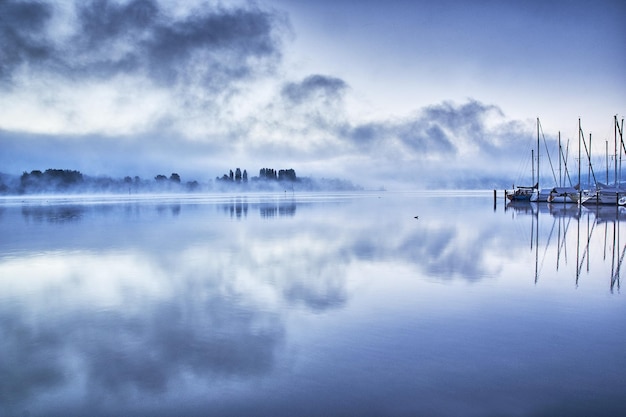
[0,254,284,410]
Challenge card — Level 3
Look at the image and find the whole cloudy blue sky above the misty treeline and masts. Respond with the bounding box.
[0,0,626,189]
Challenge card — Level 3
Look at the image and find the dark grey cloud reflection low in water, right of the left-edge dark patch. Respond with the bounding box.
[78,294,283,394]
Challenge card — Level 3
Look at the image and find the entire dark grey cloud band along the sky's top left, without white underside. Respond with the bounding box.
[0,0,282,88]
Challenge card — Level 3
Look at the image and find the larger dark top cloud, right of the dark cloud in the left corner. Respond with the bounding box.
[72,0,278,90]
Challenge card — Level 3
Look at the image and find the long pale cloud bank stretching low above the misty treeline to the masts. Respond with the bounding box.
[0,95,535,188]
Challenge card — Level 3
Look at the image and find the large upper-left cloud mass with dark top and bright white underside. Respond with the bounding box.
[0,0,289,140]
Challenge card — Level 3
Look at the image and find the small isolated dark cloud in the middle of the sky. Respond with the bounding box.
[281,74,348,104]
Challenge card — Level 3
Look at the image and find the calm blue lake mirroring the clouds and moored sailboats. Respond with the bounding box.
[0,191,626,417]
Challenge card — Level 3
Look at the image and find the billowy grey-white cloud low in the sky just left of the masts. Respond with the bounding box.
[316,99,533,188]
